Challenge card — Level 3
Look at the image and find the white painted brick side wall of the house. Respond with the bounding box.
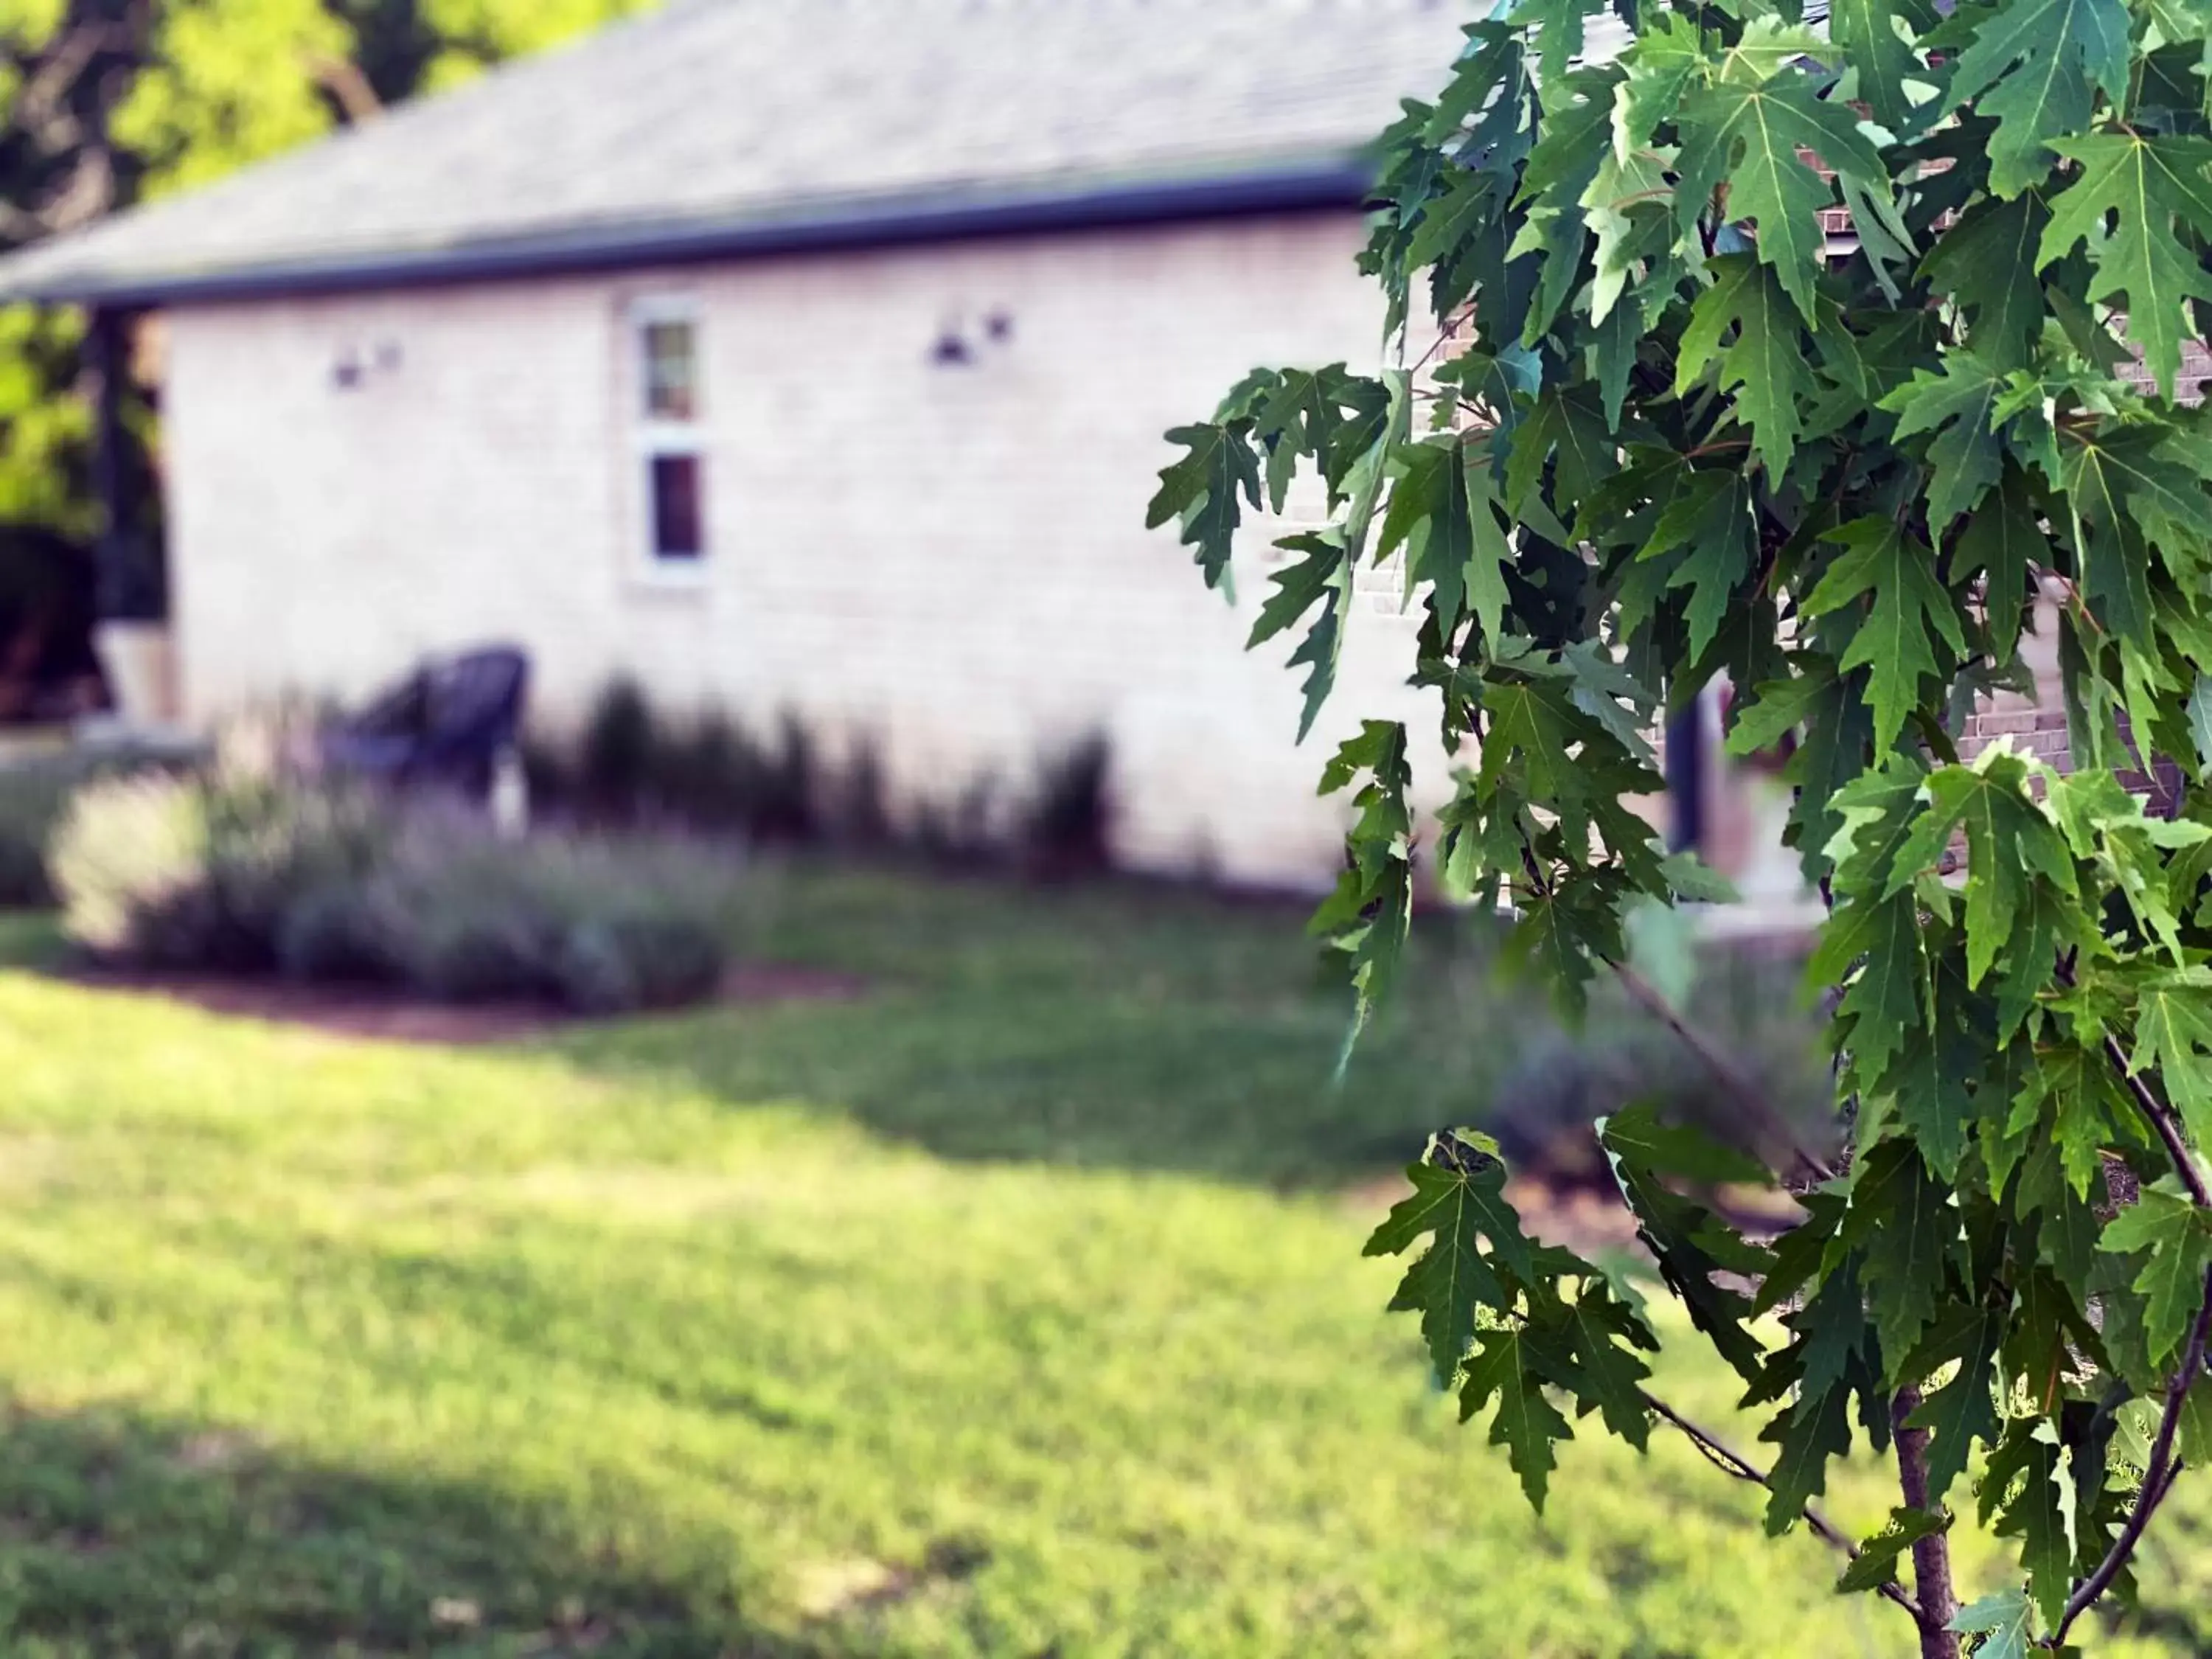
[166,215,1440,898]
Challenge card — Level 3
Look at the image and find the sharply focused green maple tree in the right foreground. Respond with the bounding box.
[1152,0,2212,1659]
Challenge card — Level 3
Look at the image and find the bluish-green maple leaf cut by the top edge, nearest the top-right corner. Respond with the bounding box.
[1944,0,2128,197]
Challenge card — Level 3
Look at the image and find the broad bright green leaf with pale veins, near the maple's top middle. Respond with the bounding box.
[1674,66,1902,323]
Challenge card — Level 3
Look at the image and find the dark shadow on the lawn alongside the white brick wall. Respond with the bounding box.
[553,878,1551,1188]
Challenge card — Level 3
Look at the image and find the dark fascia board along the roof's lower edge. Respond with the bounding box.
[26,157,1374,307]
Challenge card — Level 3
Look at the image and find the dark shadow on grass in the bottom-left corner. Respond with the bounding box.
[0,1409,816,1659]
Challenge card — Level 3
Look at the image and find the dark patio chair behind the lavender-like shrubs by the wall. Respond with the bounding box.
[323,646,531,796]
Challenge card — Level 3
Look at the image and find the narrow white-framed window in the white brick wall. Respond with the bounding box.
[626,296,710,577]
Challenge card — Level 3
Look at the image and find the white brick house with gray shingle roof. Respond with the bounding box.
[0,0,1486,898]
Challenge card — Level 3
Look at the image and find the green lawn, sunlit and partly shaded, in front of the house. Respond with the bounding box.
[0,872,2212,1659]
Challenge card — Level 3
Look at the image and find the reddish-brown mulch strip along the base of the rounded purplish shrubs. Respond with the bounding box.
[58,962,867,1046]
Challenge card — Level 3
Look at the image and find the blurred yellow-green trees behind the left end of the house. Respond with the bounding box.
[0,0,650,712]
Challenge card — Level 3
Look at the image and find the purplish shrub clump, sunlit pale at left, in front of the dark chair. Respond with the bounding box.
[53,721,739,1013]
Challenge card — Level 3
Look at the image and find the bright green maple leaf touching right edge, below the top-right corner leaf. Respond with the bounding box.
[2037,133,2212,398]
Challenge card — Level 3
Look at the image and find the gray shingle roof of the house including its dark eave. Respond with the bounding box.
[0,0,1475,301]
